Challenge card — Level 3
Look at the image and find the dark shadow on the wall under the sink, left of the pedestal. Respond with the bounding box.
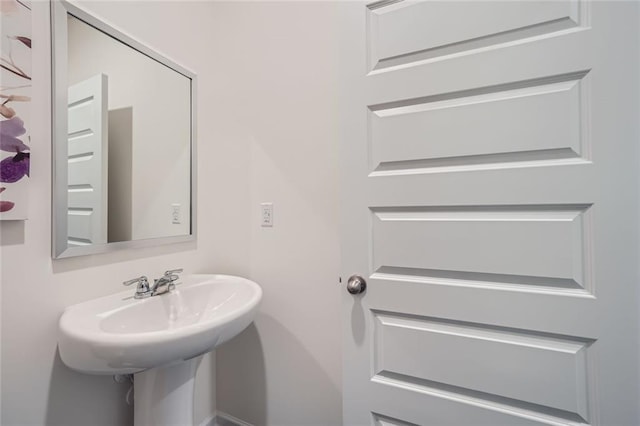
[45,350,133,426]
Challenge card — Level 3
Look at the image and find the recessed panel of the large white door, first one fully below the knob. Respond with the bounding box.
[373,312,592,418]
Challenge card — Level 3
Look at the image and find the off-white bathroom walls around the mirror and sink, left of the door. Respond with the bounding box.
[0,1,348,425]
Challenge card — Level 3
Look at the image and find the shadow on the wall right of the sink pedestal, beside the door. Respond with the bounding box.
[216,313,342,426]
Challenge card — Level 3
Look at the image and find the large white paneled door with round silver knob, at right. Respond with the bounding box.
[342,1,640,426]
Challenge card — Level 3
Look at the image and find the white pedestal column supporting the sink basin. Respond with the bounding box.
[133,356,202,426]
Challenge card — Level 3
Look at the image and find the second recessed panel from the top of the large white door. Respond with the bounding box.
[370,73,585,172]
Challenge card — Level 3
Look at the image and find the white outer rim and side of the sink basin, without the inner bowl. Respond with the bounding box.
[59,274,262,374]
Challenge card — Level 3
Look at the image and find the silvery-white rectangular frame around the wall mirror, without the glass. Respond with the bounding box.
[51,0,197,259]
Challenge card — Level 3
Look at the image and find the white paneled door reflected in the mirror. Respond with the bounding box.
[67,74,108,247]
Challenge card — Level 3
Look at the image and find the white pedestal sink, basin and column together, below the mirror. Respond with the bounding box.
[58,275,262,426]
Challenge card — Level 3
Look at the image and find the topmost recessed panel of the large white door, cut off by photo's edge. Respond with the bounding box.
[368,0,581,69]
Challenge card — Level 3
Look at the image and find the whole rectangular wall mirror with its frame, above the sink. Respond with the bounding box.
[51,1,196,258]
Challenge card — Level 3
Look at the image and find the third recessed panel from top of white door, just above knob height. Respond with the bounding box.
[372,205,589,288]
